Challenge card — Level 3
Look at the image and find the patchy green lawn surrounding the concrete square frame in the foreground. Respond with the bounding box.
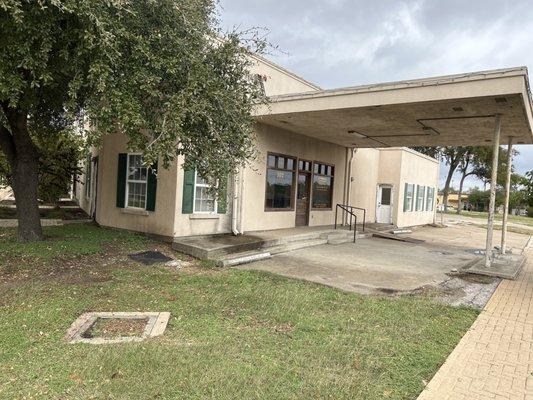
[0,225,477,400]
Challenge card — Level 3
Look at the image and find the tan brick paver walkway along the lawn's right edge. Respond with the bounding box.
[418,241,533,400]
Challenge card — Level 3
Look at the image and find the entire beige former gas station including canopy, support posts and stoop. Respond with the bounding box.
[76,56,533,276]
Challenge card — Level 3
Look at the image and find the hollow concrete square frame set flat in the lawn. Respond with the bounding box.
[65,312,170,344]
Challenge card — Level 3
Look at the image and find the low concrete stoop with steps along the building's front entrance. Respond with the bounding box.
[172,230,372,267]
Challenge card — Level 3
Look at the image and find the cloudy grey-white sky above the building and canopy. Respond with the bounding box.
[220,0,533,191]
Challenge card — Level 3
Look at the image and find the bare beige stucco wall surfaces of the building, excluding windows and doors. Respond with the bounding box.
[76,53,438,239]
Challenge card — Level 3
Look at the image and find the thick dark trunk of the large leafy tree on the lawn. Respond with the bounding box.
[0,104,43,242]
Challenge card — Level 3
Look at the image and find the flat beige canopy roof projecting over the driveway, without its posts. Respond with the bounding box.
[256,67,533,148]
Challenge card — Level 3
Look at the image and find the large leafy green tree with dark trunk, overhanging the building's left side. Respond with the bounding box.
[0,0,264,241]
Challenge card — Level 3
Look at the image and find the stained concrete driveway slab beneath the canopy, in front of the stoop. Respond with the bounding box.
[238,238,477,293]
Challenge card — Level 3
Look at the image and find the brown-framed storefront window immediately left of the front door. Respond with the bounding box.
[265,154,296,210]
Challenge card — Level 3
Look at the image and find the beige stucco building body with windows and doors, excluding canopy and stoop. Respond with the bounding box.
[76,57,438,240]
